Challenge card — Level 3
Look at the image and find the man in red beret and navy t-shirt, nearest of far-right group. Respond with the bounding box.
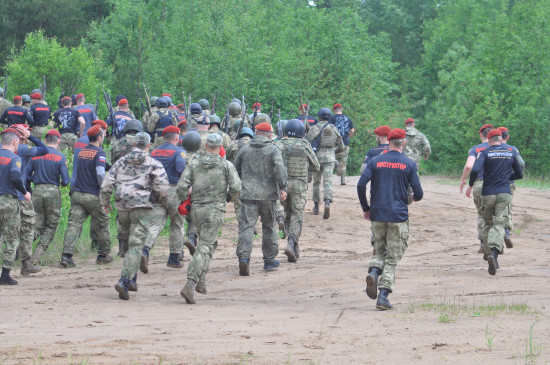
[466,129,523,275]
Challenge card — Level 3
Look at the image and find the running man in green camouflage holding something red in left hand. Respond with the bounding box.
[176,134,241,304]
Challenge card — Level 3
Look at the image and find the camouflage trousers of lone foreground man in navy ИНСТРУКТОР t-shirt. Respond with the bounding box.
[369,220,409,292]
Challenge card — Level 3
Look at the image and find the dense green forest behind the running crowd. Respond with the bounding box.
[0,0,550,176]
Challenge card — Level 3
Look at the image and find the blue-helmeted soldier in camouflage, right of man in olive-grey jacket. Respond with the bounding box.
[278,119,320,262]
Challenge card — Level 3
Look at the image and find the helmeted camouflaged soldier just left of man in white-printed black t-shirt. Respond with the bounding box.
[306,108,344,219]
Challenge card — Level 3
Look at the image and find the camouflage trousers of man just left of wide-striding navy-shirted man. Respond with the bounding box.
[32,184,61,251]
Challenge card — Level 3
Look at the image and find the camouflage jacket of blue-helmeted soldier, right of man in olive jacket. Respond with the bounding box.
[275,137,320,184]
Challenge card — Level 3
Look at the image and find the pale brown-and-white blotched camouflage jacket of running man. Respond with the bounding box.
[99,148,169,211]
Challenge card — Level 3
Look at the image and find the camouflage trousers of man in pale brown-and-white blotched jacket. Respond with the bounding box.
[118,208,151,279]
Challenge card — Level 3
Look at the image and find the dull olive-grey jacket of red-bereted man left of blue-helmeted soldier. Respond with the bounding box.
[235,136,287,200]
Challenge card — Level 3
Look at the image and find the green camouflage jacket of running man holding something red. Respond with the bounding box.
[176,153,241,212]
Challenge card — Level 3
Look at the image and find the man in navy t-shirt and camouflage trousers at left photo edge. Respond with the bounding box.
[0,128,31,285]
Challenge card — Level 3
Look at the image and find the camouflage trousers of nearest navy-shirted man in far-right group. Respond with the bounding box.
[481,194,512,254]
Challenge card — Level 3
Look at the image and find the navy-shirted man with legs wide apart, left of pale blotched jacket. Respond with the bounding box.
[60,125,113,267]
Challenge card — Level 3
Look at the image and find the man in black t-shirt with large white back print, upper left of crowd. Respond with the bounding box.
[53,96,86,151]
